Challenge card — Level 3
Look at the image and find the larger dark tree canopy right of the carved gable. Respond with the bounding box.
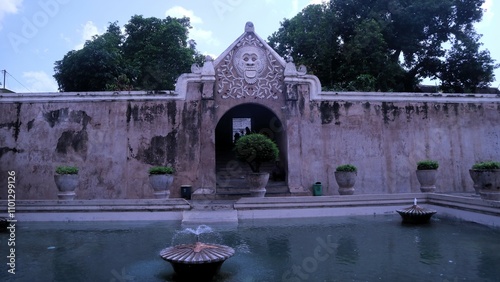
[268,0,498,92]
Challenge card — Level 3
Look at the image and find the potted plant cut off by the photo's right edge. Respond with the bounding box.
[469,161,500,201]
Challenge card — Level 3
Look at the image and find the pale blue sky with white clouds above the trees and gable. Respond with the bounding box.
[0,0,500,92]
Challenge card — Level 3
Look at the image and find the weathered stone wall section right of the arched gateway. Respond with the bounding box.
[292,93,500,194]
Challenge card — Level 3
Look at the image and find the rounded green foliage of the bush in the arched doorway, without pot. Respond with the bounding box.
[234,133,279,172]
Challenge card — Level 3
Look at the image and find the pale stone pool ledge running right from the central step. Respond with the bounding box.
[234,193,500,226]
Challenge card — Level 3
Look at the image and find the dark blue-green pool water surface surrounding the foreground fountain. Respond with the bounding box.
[0,214,500,282]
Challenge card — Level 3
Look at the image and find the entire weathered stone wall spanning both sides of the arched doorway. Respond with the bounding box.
[0,89,500,199]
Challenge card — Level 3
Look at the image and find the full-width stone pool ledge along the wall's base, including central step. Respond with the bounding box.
[0,193,500,226]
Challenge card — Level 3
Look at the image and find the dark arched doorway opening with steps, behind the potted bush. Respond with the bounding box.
[215,103,288,196]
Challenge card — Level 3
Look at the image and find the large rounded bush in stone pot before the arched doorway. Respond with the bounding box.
[234,133,279,197]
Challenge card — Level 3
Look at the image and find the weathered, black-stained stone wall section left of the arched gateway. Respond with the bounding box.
[0,89,200,199]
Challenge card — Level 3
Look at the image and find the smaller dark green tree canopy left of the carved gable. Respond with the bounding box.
[54,15,202,91]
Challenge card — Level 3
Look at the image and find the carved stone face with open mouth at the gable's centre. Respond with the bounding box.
[234,46,266,84]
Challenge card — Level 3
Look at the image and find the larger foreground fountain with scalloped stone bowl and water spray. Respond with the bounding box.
[160,225,234,281]
